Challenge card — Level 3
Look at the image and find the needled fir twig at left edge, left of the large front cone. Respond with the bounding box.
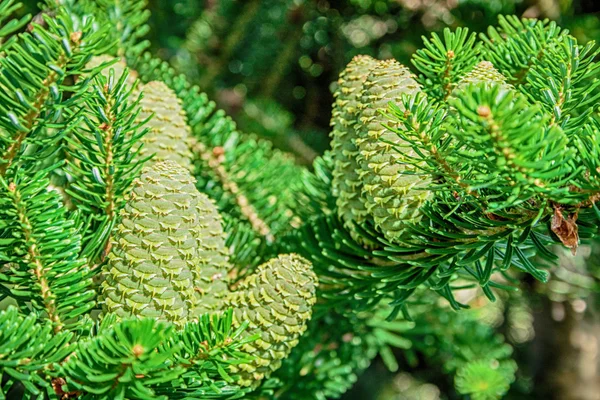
[0,171,95,332]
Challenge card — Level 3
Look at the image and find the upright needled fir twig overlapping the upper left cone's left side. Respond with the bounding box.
[66,59,146,262]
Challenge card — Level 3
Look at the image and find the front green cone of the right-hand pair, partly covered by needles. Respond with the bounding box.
[356,60,431,241]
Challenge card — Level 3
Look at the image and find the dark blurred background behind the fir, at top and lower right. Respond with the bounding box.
[18,0,600,400]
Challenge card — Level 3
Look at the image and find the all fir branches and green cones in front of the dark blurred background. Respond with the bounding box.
[0,0,600,400]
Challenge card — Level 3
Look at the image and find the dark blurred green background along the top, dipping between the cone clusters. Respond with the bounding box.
[17,0,600,164]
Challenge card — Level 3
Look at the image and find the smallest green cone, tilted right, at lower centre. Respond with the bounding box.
[225,254,317,387]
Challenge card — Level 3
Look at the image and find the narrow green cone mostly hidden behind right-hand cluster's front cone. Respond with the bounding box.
[331,55,377,244]
